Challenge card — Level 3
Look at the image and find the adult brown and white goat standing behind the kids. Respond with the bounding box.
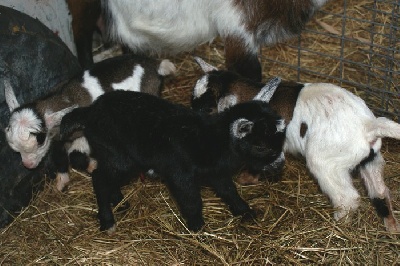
[68,0,328,81]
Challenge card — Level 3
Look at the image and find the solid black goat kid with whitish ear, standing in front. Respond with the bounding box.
[60,85,285,232]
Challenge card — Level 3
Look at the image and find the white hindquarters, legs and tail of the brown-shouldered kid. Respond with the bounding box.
[284,83,400,232]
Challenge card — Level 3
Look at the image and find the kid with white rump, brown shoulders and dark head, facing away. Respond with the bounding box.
[192,58,400,232]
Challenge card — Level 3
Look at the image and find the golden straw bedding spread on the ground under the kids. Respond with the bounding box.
[0,1,400,265]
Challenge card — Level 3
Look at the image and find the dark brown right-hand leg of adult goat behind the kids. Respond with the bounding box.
[225,36,262,82]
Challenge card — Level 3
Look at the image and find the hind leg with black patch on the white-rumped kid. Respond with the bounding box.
[360,152,400,232]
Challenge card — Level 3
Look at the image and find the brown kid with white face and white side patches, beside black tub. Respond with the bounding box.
[4,55,175,190]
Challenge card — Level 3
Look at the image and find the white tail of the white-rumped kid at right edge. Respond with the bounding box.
[368,117,400,139]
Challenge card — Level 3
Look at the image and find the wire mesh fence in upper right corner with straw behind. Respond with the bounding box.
[262,0,400,121]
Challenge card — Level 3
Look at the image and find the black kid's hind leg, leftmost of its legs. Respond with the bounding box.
[92,168,115,233]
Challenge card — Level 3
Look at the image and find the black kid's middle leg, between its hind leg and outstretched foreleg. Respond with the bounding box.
[166,175,204,232]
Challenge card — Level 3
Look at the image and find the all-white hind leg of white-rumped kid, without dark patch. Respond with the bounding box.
[307,157,360,220]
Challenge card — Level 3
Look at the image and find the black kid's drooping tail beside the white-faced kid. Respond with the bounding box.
[60,107,88,141]
